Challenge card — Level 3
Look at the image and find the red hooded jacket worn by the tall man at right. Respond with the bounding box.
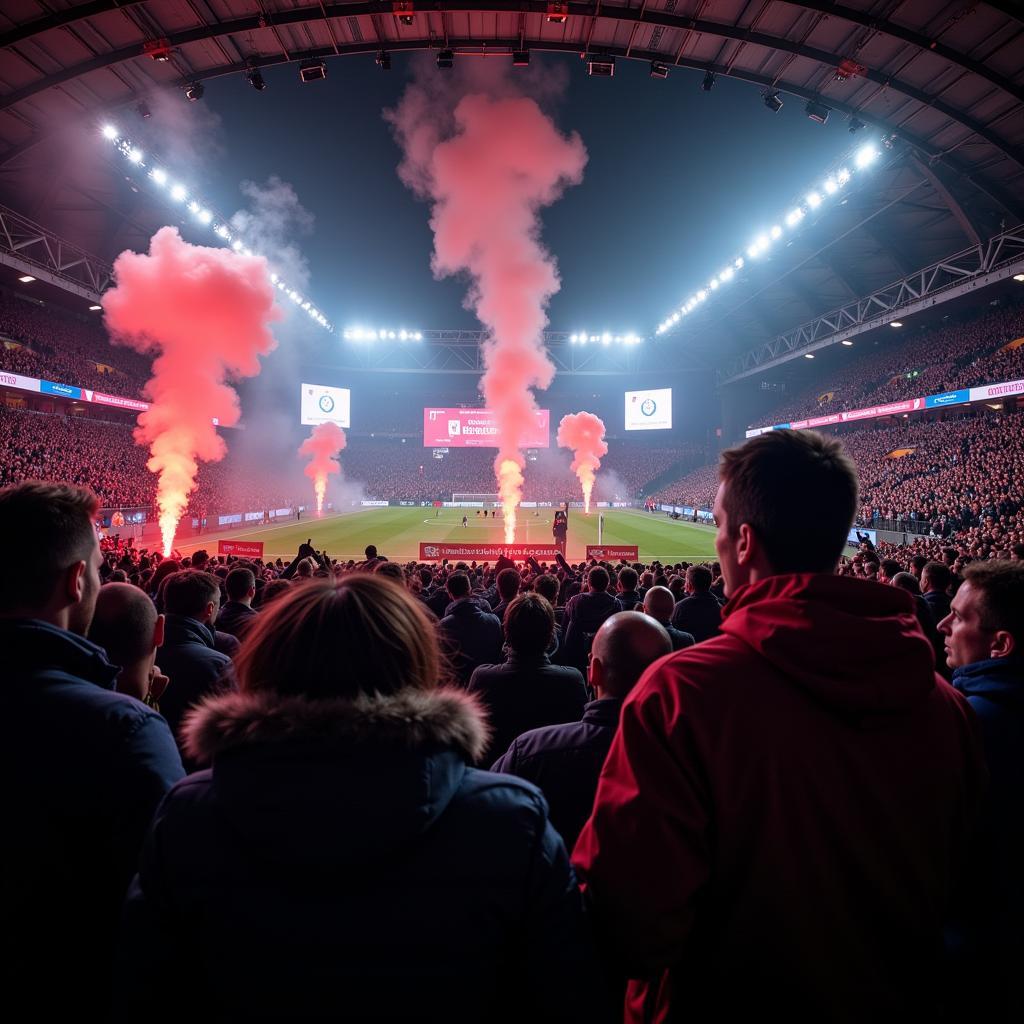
[573,573,985,1022]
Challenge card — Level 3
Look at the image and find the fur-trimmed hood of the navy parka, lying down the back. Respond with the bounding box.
[182,688,489,864]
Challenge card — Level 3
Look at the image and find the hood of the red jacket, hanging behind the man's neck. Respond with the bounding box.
[722,572,935,715]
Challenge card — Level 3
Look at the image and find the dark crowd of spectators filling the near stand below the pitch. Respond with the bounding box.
[6,421,1024,1024]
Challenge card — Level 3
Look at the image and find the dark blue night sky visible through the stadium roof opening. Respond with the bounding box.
[186,53,853,334]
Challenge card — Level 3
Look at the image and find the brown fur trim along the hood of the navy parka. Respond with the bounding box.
[182,687,490,763]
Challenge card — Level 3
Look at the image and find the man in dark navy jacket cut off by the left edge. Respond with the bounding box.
[0,483,183,1020]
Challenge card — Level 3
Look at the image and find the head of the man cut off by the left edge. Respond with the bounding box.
[0,483,103,636]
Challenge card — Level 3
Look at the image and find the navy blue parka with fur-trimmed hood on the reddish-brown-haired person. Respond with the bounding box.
[119,689,593,1024]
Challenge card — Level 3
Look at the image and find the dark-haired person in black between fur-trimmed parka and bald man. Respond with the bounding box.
[469,594,587,764]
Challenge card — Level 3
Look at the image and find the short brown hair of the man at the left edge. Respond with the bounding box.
[0,481,99,611]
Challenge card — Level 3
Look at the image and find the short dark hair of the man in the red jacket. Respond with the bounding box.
[719,430,857,572]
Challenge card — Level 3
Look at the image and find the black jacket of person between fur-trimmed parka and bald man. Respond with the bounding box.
[469,653,587,765]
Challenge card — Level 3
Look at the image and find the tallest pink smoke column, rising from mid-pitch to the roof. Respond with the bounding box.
[386,61,587,543]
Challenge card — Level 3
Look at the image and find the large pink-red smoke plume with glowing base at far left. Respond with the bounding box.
[102,227,282,554]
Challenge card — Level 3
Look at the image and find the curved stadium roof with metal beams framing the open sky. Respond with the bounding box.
[0,0,1024,372]
